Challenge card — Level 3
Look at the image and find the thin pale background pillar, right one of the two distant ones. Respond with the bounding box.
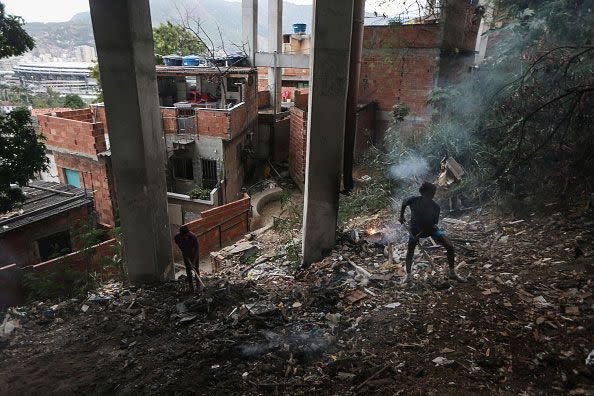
[268,0,283,113]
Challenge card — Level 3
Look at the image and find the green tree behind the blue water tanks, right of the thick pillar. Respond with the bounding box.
[153,22,206,63]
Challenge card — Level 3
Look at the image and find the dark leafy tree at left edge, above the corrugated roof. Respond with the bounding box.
[0,109,48,213]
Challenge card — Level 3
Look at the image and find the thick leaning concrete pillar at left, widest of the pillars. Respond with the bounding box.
[89,0,173,284]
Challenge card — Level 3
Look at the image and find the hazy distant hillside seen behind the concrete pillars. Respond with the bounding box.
[25,0,312,53]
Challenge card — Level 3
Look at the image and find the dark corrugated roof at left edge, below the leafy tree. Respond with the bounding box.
[0,181,93,235]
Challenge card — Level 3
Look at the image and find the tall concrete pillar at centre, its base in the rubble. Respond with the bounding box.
[303,0,353,265]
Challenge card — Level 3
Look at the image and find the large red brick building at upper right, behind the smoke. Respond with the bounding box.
[359,0,481,132]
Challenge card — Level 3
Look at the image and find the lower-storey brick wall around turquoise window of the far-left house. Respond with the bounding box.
[54,152,115,226]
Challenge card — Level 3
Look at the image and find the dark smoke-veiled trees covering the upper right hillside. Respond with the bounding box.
[388,0,594,208]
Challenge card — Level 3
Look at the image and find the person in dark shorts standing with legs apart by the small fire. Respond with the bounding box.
[400,182,466,283]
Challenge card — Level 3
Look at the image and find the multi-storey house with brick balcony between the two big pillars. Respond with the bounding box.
[157,66,258,225]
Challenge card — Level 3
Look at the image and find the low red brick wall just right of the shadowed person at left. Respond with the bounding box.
[173,194,251,258]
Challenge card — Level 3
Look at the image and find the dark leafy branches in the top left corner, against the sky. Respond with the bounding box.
[0,3,35,58]
